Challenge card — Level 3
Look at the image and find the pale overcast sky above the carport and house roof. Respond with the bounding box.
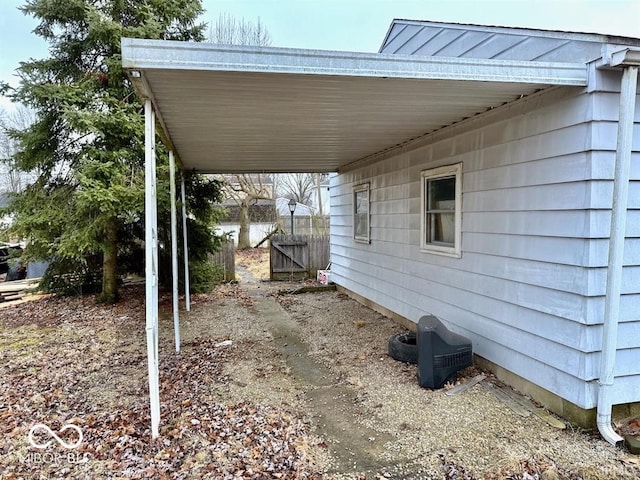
[0,0,640,110]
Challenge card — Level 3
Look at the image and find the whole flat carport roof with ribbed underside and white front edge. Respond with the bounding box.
[122,38,586,173]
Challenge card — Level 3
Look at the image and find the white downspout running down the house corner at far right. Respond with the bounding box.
[596,62,638,445]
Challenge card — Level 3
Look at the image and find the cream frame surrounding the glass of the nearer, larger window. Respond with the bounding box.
[420,163,462,258]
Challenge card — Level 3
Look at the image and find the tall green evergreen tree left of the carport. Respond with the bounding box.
[3,0,218,302]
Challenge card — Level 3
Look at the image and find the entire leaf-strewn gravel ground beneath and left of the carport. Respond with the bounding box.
[0,253,640,480]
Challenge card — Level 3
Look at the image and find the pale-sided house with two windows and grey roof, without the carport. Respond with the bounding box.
[331,20,640,430]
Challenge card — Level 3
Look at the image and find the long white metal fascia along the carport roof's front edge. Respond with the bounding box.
[122,38,587,86]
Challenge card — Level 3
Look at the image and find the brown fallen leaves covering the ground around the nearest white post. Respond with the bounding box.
[0,288,319,479]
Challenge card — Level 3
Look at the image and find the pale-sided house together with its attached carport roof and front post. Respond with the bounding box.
[122,20,640,443]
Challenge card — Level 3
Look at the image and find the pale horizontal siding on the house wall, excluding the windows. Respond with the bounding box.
[331,79,640,408]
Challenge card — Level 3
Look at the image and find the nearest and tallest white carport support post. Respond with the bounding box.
[144,100,160,439]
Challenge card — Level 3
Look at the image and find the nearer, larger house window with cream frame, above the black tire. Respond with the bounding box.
[421,163,462,257]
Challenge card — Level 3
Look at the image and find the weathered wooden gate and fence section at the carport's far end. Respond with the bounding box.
[270,235,329,280]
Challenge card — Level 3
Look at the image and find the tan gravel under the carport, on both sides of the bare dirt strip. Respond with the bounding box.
[181,258,640,479]
